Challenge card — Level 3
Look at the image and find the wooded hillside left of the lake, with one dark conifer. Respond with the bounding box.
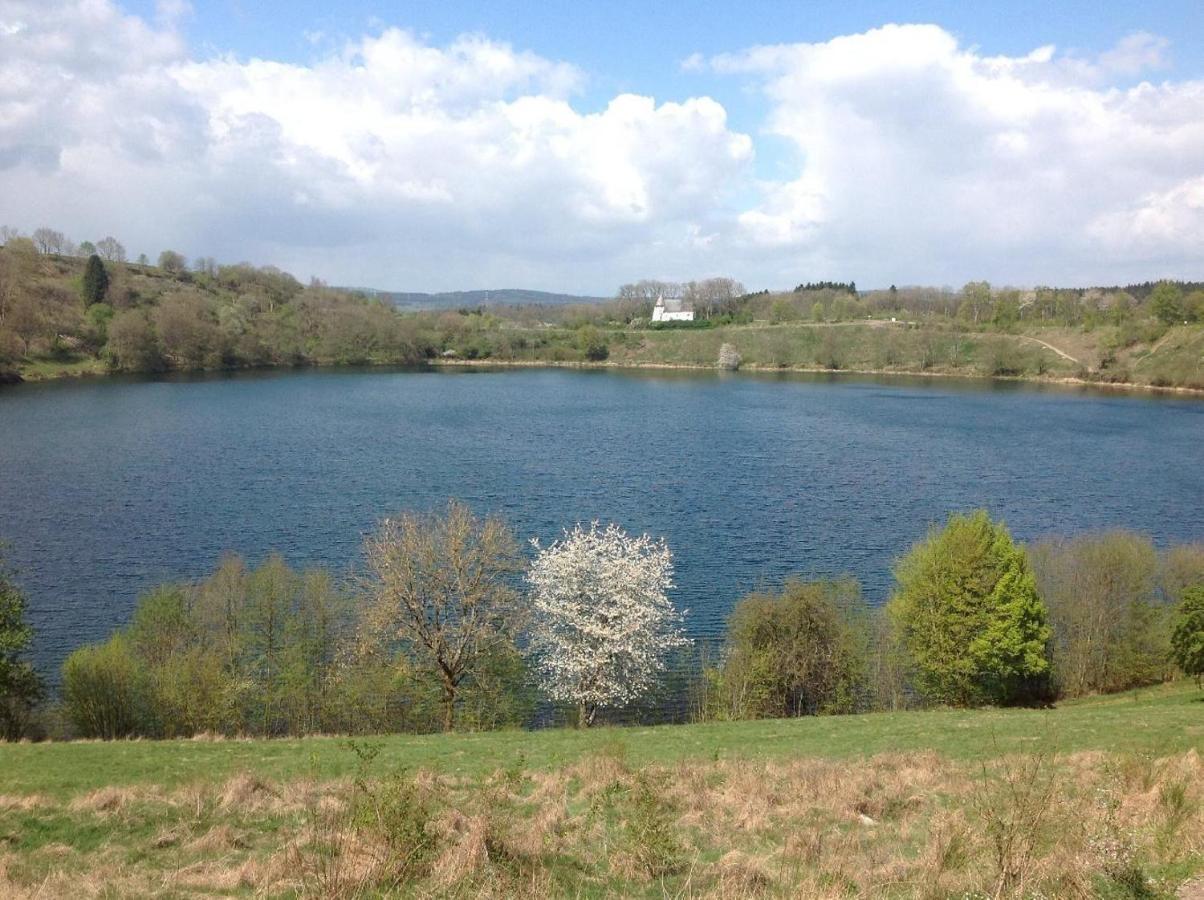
[0,229,433,372]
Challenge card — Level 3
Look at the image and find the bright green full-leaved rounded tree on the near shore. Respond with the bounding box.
[889,510,1051,706]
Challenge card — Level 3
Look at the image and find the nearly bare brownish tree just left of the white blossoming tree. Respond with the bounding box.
[364,501,520,732]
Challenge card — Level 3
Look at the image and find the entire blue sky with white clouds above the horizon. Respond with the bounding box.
[0,0,1204,296]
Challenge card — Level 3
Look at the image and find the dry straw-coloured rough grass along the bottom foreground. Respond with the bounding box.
[0,751,1204,899]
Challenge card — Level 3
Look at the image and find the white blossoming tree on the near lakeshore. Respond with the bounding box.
[527,522,689,727]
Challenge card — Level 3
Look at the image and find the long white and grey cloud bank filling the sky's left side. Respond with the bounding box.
[0,0,753,289]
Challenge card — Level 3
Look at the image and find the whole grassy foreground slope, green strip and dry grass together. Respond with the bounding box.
[0,683,1204,896]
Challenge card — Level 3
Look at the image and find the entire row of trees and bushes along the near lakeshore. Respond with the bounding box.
[0,510,1204,739]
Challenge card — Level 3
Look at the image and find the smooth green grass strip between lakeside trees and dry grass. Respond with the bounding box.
[0,682,1204,797]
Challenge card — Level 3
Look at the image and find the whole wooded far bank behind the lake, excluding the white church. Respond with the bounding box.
[0,229,1204,389]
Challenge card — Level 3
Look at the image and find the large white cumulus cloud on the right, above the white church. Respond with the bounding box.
[712,25,1204,283]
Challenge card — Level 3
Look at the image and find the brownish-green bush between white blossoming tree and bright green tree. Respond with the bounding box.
[704,578,869,718]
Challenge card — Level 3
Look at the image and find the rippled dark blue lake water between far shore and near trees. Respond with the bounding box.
[0,369,1204,671]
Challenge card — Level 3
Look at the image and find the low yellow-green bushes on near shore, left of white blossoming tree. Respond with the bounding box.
[51,556,536,739]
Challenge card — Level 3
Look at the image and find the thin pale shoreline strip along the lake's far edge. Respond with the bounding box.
[9,359,1204,397]
